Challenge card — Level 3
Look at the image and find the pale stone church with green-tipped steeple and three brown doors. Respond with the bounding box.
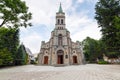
[38,4,84,66]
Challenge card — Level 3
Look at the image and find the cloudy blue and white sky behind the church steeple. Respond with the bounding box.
[20,0,101,54]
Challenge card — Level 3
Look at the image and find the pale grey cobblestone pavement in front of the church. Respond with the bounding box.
[0,64,120,80]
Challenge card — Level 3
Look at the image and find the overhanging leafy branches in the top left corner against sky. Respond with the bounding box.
[0,0,32,28]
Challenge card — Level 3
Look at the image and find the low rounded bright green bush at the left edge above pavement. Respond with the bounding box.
[0,48,13,66]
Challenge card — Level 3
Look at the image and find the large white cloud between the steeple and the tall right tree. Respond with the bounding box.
[66,12,101,41]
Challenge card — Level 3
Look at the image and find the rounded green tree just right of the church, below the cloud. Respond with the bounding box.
[82,37,105,62]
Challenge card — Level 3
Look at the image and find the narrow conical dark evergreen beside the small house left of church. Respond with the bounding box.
[16,44,28,65]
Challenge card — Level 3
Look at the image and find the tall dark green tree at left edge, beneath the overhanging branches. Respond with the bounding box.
[0,27,19,64]
